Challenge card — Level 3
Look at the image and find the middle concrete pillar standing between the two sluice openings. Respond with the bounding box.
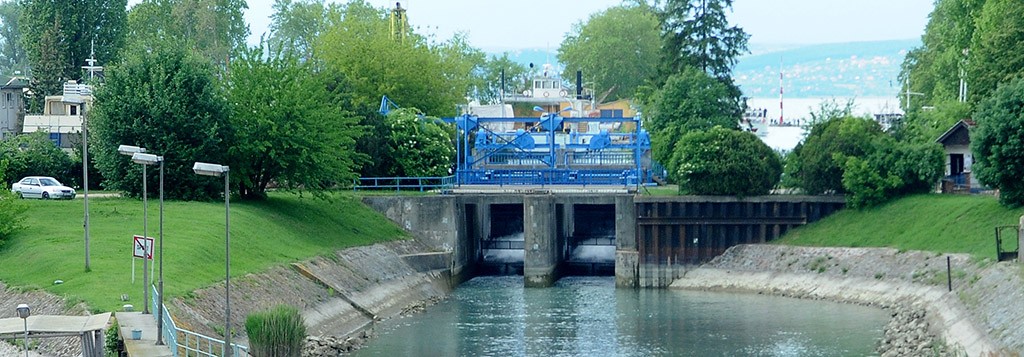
[522,195,561,287]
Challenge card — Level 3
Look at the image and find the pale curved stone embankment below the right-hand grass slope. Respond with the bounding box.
[671,244,1024,356]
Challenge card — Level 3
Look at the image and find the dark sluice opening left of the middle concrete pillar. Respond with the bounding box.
[478,204,525,275]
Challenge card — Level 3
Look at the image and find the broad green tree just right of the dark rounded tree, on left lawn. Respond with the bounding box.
[227,46,361,197]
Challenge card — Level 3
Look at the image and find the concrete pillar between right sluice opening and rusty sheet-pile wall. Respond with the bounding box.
[615,195,640,287]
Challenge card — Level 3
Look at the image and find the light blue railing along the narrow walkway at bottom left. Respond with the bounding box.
[150,286,249,357]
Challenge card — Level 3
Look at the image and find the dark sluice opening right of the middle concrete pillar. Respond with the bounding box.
[563,204,615,276]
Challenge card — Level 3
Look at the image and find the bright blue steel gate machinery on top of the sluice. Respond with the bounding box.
[444,107,653,186]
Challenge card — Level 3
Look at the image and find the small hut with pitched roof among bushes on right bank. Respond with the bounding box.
[935,119,980,193]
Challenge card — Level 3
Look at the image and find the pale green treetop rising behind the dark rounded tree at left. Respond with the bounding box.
[128,0,249,66]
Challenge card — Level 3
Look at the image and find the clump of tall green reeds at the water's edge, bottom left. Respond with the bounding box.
[246,305,306,357]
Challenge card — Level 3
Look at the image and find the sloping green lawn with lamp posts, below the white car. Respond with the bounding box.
[0,193,407,311]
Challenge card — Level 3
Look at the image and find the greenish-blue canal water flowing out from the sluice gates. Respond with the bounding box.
[355,276,889,356]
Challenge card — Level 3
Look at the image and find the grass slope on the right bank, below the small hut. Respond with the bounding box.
[776,194,1024,259]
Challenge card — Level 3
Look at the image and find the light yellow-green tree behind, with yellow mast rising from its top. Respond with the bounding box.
[314,1,484,116]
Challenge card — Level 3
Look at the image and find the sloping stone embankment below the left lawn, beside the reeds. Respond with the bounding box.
[168,236,451,356]
